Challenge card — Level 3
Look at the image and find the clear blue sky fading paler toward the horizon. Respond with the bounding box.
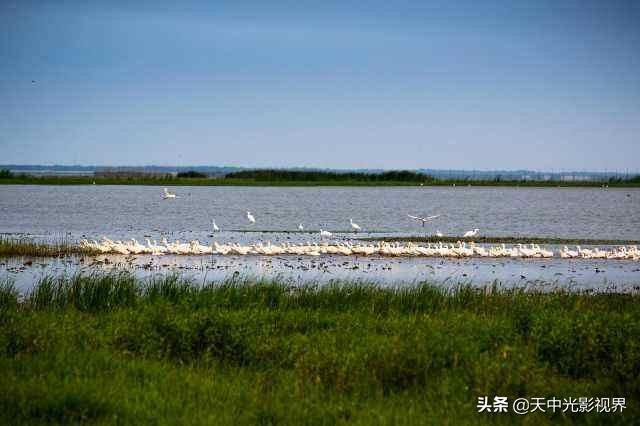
[0,0,640,171]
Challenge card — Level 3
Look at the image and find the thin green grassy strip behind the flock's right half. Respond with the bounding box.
[360,235,640,246]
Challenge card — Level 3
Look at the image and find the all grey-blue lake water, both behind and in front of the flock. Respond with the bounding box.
[0,186,640,291]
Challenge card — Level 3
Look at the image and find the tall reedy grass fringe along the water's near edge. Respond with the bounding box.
[15,271,640,315]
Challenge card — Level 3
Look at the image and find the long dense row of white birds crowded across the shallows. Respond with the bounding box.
[80,237,640,260]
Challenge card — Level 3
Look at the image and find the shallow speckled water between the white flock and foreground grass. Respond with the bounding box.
[0,255,640,292]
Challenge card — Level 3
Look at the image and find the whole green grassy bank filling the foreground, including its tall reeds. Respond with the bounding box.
[0,275,640,425]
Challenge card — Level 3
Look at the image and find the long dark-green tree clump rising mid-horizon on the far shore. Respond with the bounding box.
[225,169,434,183]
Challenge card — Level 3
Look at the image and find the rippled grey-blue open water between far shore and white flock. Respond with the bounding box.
[0,185,640,241]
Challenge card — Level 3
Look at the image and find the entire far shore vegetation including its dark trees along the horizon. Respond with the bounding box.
[0,169,640,188]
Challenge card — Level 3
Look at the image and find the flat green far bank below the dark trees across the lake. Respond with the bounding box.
[0,175,640,188]
